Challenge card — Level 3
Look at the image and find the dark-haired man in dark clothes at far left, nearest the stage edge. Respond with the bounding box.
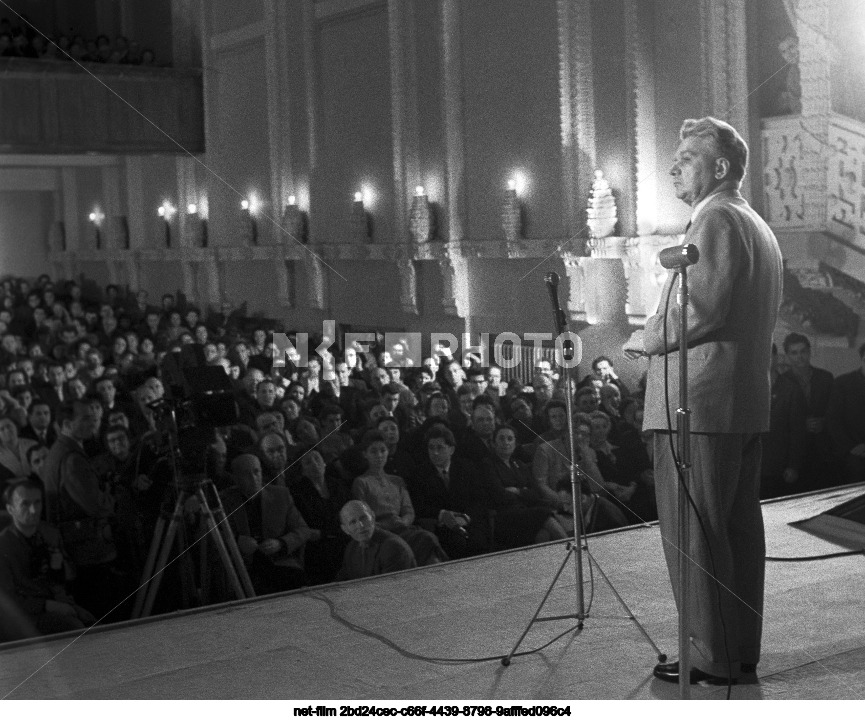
[0,478,96,641]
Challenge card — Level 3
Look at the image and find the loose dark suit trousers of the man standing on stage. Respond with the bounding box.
[654,431,766,678]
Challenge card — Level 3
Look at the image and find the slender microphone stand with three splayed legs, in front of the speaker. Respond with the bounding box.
[502,273,666,666]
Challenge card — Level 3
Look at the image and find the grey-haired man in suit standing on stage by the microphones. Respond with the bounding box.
[625,118,782,684]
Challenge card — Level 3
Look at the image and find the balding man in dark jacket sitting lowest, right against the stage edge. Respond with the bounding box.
[336,501,417,581]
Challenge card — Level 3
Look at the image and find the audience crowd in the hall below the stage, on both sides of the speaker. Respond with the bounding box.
[0,268,836,633]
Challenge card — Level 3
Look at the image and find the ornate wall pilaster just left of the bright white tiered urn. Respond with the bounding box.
[558,0,597,238]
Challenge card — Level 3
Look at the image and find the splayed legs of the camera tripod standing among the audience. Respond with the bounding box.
[132,479,255,618]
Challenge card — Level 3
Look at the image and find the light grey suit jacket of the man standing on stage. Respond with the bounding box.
[643,190,782,433]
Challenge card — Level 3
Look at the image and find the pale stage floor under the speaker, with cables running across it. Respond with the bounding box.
[0,486,865,700]
